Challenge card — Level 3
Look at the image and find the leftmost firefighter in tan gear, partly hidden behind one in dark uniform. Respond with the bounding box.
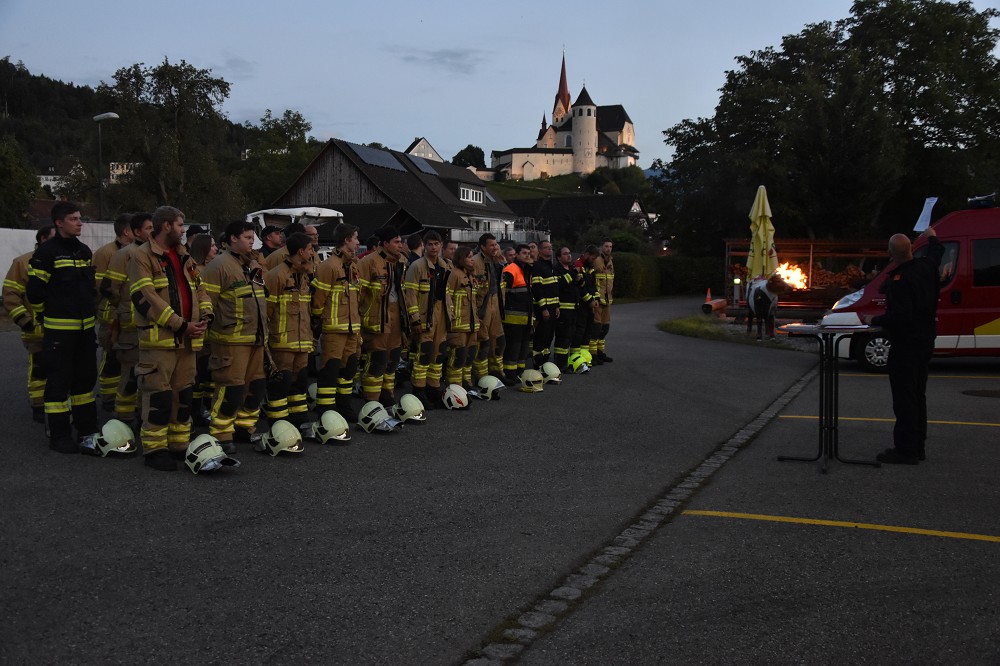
[3,224,56,423]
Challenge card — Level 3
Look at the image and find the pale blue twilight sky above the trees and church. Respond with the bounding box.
[0,0,996,168]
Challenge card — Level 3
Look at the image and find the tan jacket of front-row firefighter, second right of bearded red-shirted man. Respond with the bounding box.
[264,253,315,352]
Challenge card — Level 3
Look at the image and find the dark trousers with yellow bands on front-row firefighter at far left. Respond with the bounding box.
[42,328,97,442]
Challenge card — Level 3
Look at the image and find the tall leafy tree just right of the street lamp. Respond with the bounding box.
[98,58,245,220]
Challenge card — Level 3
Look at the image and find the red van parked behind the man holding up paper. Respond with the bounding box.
[821,208,1000,371]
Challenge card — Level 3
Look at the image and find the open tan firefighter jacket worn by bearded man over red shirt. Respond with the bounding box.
[128,238,212,351]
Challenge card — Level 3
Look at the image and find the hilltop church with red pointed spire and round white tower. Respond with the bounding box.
[490,53,639,180]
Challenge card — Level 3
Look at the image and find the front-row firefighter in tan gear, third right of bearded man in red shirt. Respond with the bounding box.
[312,223,361,423]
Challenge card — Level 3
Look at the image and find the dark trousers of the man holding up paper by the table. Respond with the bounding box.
[888,342,931,456]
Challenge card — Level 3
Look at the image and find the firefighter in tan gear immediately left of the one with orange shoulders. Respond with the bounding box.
[472,233,506,381]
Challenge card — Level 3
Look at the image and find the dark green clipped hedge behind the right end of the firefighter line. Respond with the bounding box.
[600,252,725,298]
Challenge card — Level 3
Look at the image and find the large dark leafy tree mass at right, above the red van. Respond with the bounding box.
[654,0,1000,253]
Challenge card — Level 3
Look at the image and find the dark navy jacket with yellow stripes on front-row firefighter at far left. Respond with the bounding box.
[27,233,97,331]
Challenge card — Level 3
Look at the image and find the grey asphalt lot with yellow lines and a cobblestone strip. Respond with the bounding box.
[0,299,1000,664]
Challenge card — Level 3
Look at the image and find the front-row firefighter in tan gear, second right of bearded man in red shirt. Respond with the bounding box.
[264,232,314,427]
